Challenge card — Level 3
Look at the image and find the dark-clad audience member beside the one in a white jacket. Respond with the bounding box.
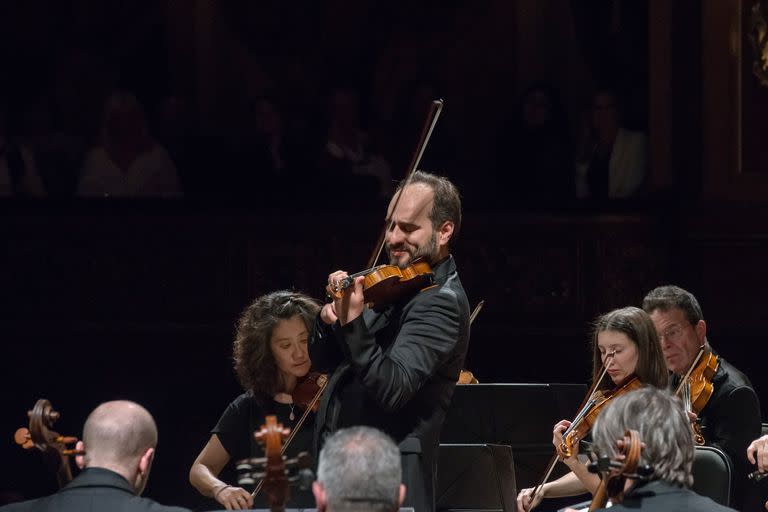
[496,83,574,203]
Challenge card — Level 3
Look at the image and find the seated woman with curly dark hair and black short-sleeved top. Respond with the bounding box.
[189,291,320,510]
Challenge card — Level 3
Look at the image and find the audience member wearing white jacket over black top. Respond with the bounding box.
[576,88,647,201]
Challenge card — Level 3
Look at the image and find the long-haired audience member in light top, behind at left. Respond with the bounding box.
[77,92,181,197]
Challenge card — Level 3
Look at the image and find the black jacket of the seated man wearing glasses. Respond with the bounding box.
[699,357,761,508]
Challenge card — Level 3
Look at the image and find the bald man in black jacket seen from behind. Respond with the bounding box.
[0,400,188,512]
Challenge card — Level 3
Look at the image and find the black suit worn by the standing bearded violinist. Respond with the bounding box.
[309,256,469,512]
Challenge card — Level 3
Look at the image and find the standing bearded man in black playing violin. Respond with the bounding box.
[309,171,469,512]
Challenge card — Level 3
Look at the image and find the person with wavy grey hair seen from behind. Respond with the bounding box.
[592,387,733,512]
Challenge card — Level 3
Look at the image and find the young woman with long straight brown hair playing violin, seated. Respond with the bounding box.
[517,307,669,512]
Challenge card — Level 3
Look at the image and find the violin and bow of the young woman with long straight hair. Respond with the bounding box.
[529,352,643,512]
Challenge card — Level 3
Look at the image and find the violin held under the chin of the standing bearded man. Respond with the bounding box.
[327,260,435,307]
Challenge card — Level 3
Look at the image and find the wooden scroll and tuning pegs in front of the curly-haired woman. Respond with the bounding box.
[236,416,314,512]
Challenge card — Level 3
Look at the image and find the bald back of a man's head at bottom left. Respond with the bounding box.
[83,400,157,469]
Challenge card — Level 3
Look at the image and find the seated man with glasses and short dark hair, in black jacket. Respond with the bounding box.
[643,286,760,510]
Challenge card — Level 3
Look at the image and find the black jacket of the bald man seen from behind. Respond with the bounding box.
[0,468,189,512]
